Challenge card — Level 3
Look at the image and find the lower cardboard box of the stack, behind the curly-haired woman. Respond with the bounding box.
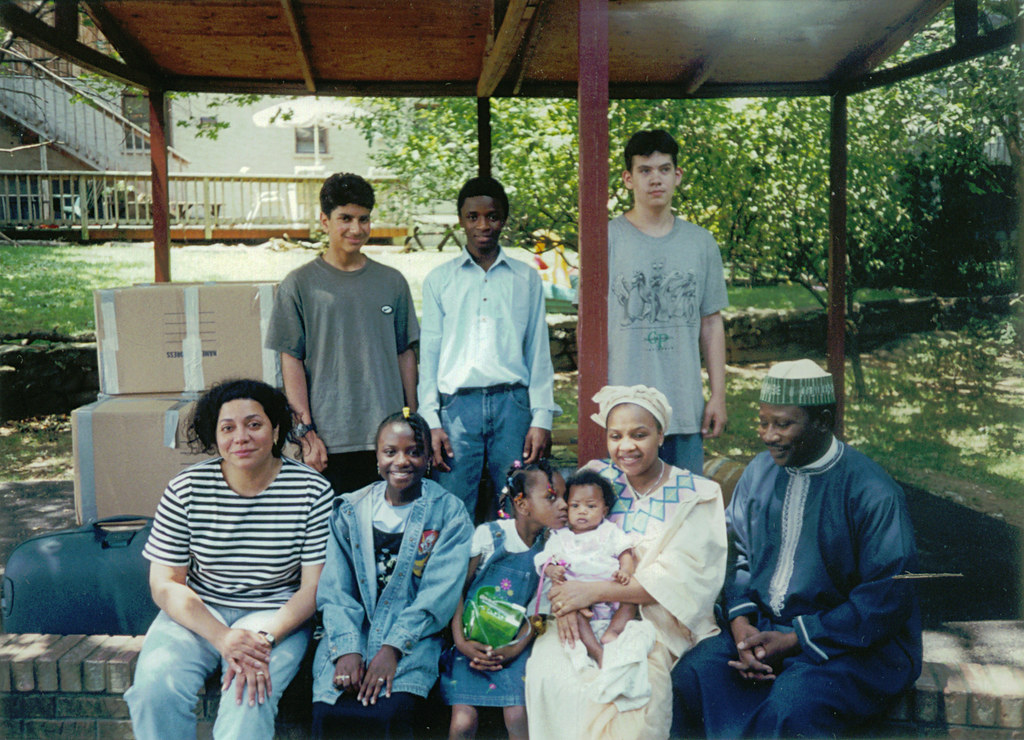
[71,396,212,524]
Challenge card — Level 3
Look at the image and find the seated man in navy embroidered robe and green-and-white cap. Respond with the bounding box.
[672,360,922,738]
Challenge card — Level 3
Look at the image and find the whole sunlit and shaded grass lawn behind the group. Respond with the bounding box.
[0,245,1024,525]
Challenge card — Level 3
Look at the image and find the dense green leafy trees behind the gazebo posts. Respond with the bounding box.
[346,0,1024,298]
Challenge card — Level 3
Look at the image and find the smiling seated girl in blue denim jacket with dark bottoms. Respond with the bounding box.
[313,408,473,738]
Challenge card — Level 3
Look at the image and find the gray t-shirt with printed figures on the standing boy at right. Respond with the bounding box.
[608,216,729,434]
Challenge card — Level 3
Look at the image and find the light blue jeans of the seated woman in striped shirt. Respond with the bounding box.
[125,604,309,740]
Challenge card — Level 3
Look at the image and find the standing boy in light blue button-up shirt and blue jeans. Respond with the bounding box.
[419,177,561,516]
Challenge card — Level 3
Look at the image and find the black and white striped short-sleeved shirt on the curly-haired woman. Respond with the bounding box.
[143,458,334,608]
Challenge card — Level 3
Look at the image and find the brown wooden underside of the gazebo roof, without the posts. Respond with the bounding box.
[0,0,1015,98]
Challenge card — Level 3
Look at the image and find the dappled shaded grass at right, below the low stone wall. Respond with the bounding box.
[705,319,1024,509]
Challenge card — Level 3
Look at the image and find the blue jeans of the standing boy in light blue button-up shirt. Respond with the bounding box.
[434,386,532,518]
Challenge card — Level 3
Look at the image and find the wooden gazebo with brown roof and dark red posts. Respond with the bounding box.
[0,0,1021,459]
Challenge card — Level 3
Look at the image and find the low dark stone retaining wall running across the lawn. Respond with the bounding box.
[0,296,1014,420]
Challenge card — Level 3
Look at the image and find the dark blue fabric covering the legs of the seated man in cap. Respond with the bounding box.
[672,629,916,738]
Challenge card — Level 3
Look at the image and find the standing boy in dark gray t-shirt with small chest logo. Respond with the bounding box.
[266,173,420,493]
